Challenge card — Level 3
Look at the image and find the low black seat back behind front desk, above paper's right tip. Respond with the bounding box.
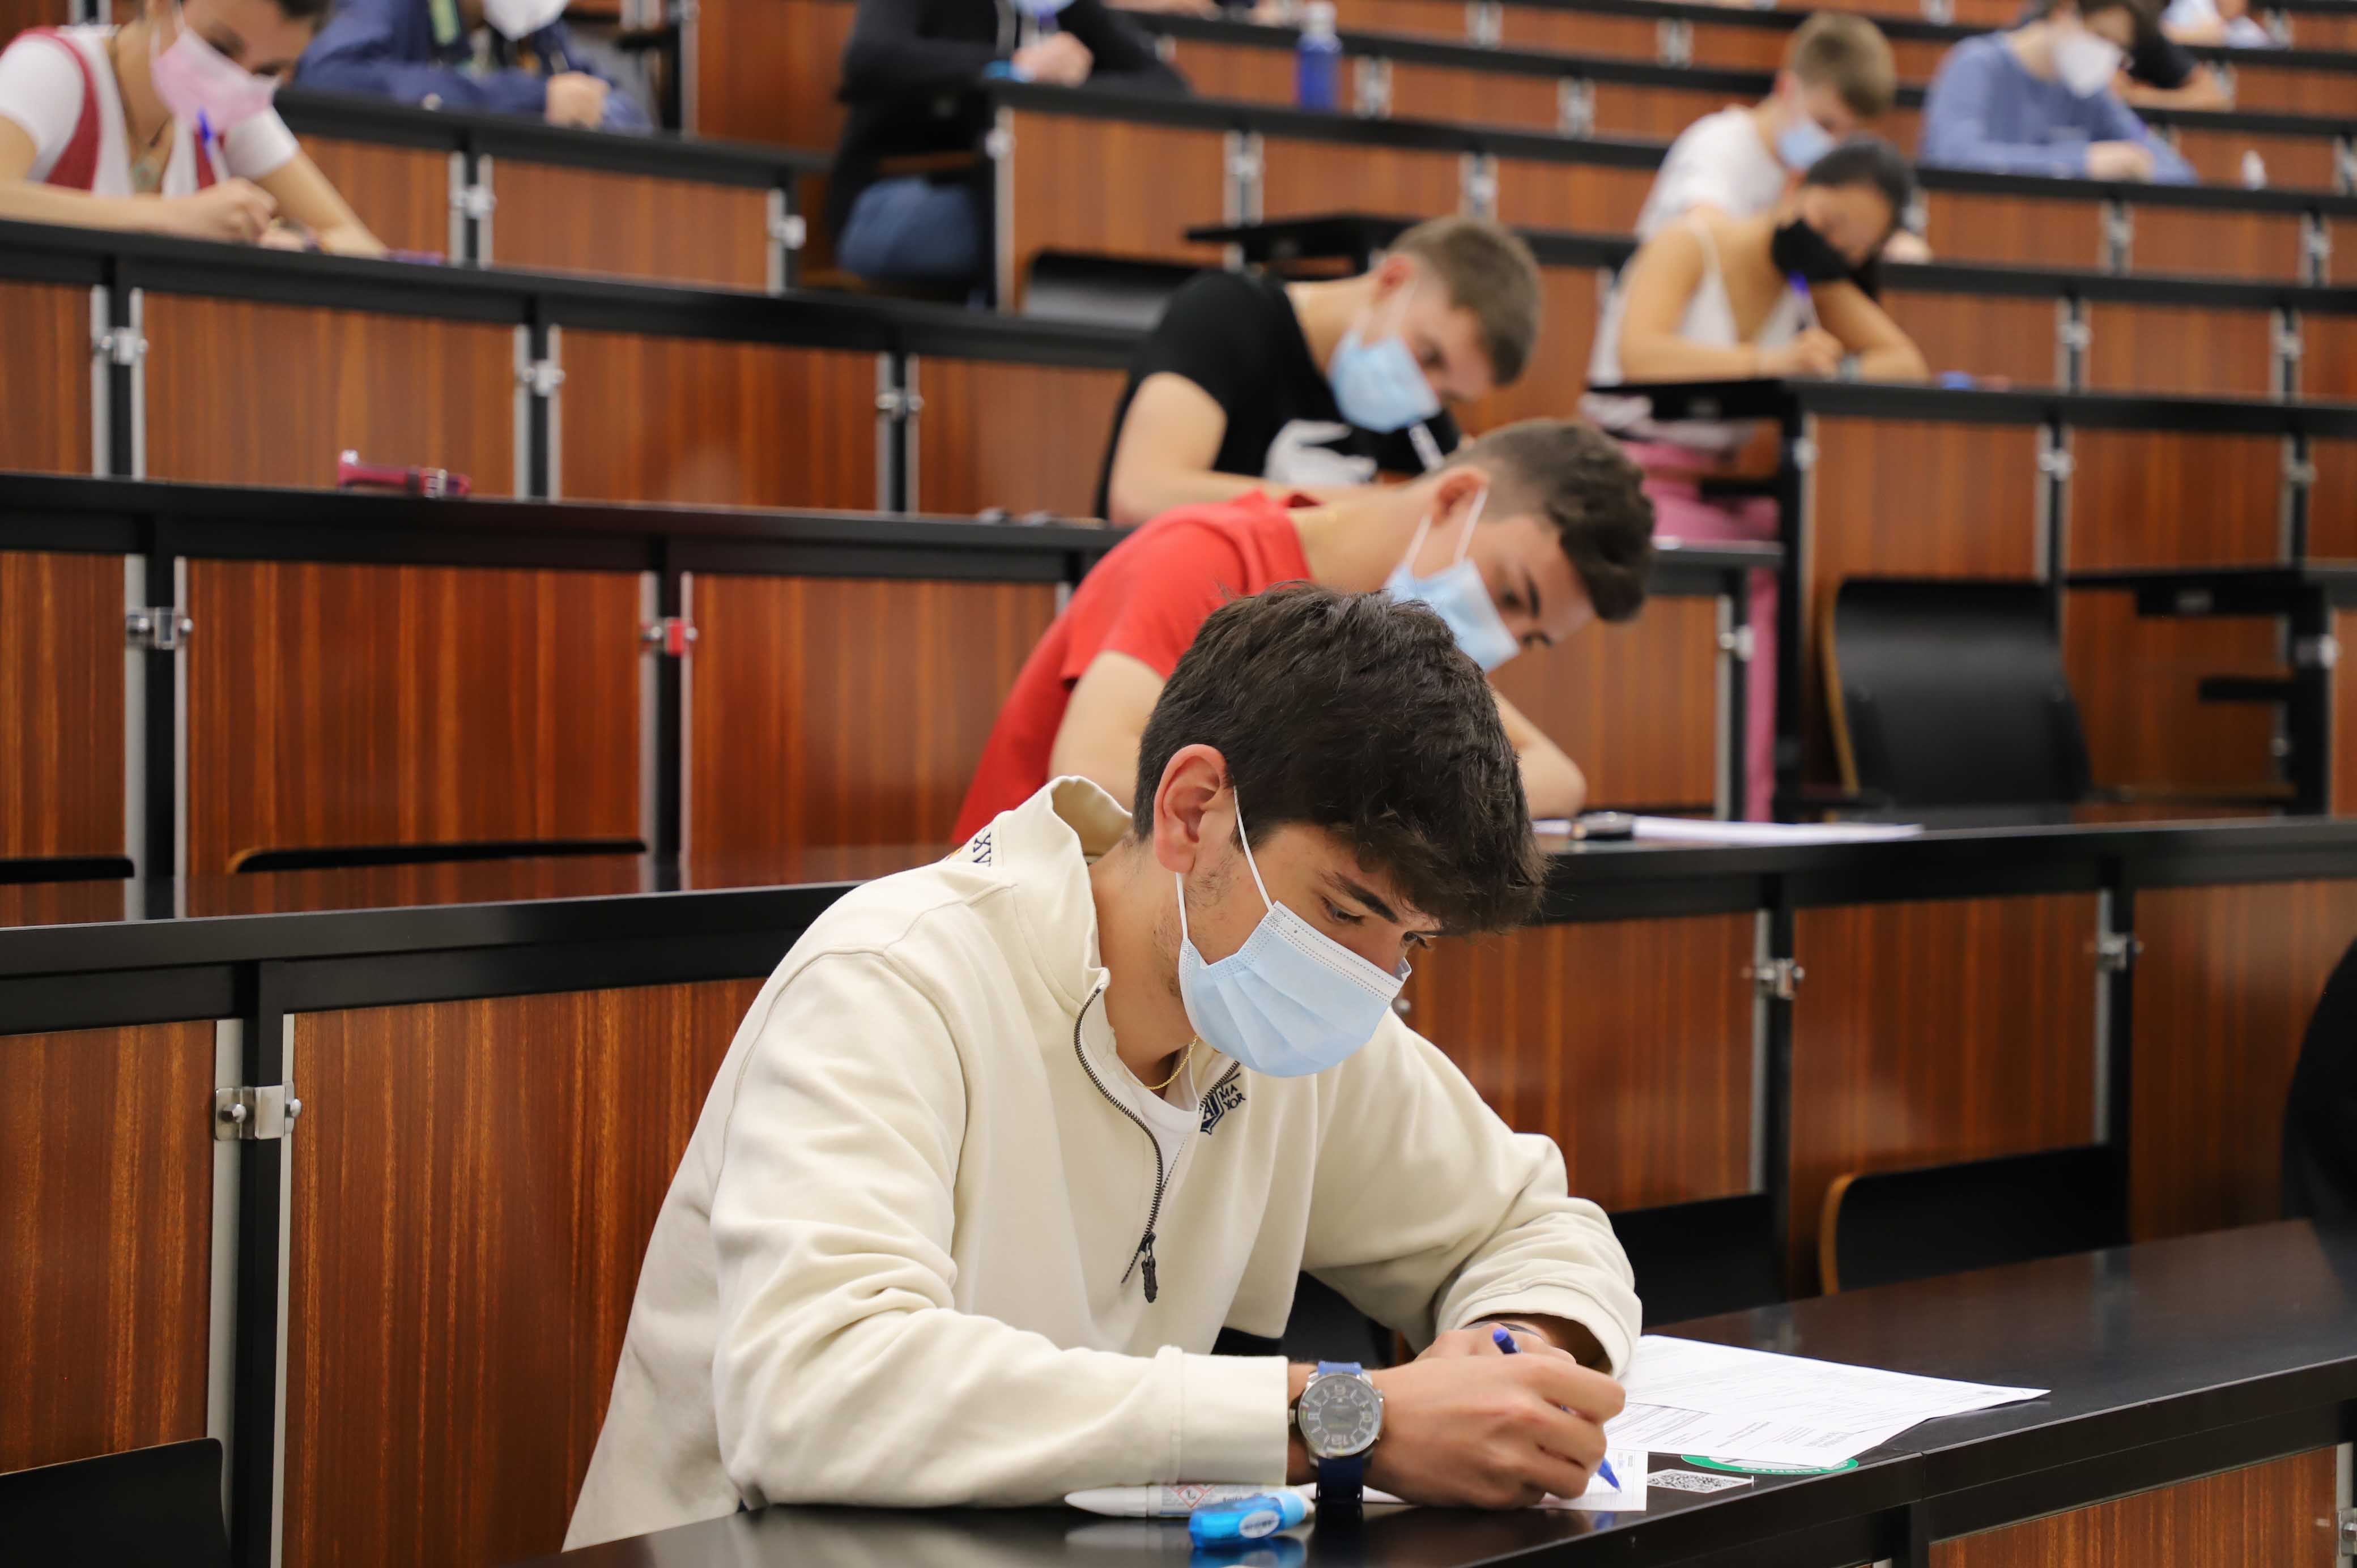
[1817,1144,2128,1292]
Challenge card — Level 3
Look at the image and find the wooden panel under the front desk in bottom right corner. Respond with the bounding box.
[1930,1448,2347,1568]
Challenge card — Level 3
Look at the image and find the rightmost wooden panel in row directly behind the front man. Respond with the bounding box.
[2128,882,2357,1240]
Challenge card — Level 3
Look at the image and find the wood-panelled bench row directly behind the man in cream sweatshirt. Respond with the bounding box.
[0,823,2357,1568]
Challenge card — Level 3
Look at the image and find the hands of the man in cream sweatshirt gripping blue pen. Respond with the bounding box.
[1367,1330,1626,1509]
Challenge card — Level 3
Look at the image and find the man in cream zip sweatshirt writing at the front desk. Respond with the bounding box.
[565,587,1638,1547]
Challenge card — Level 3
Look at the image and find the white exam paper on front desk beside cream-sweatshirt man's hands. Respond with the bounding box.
[1605,1335,2046,1469]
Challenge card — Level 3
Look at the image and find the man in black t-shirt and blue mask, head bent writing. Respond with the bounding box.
[1096,217,1539,523]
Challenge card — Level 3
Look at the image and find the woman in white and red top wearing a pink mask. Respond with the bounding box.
[0,0,384,255]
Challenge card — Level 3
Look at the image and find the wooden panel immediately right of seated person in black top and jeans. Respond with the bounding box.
[1002,111,1226,295]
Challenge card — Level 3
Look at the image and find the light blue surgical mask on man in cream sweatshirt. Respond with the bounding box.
[1176,802,1407,1077]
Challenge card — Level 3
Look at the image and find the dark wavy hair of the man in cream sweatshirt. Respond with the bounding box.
[1134,582,1546,934]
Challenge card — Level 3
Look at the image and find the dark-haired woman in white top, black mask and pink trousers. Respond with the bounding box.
[1584,137,1928,816]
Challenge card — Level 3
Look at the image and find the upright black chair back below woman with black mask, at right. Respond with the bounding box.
[1824,578,2088,809]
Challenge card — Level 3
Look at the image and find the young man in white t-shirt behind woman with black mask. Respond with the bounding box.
[1636,12,1928,262]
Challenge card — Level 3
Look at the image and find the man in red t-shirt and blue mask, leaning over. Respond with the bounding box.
[955,420,1652,840]
